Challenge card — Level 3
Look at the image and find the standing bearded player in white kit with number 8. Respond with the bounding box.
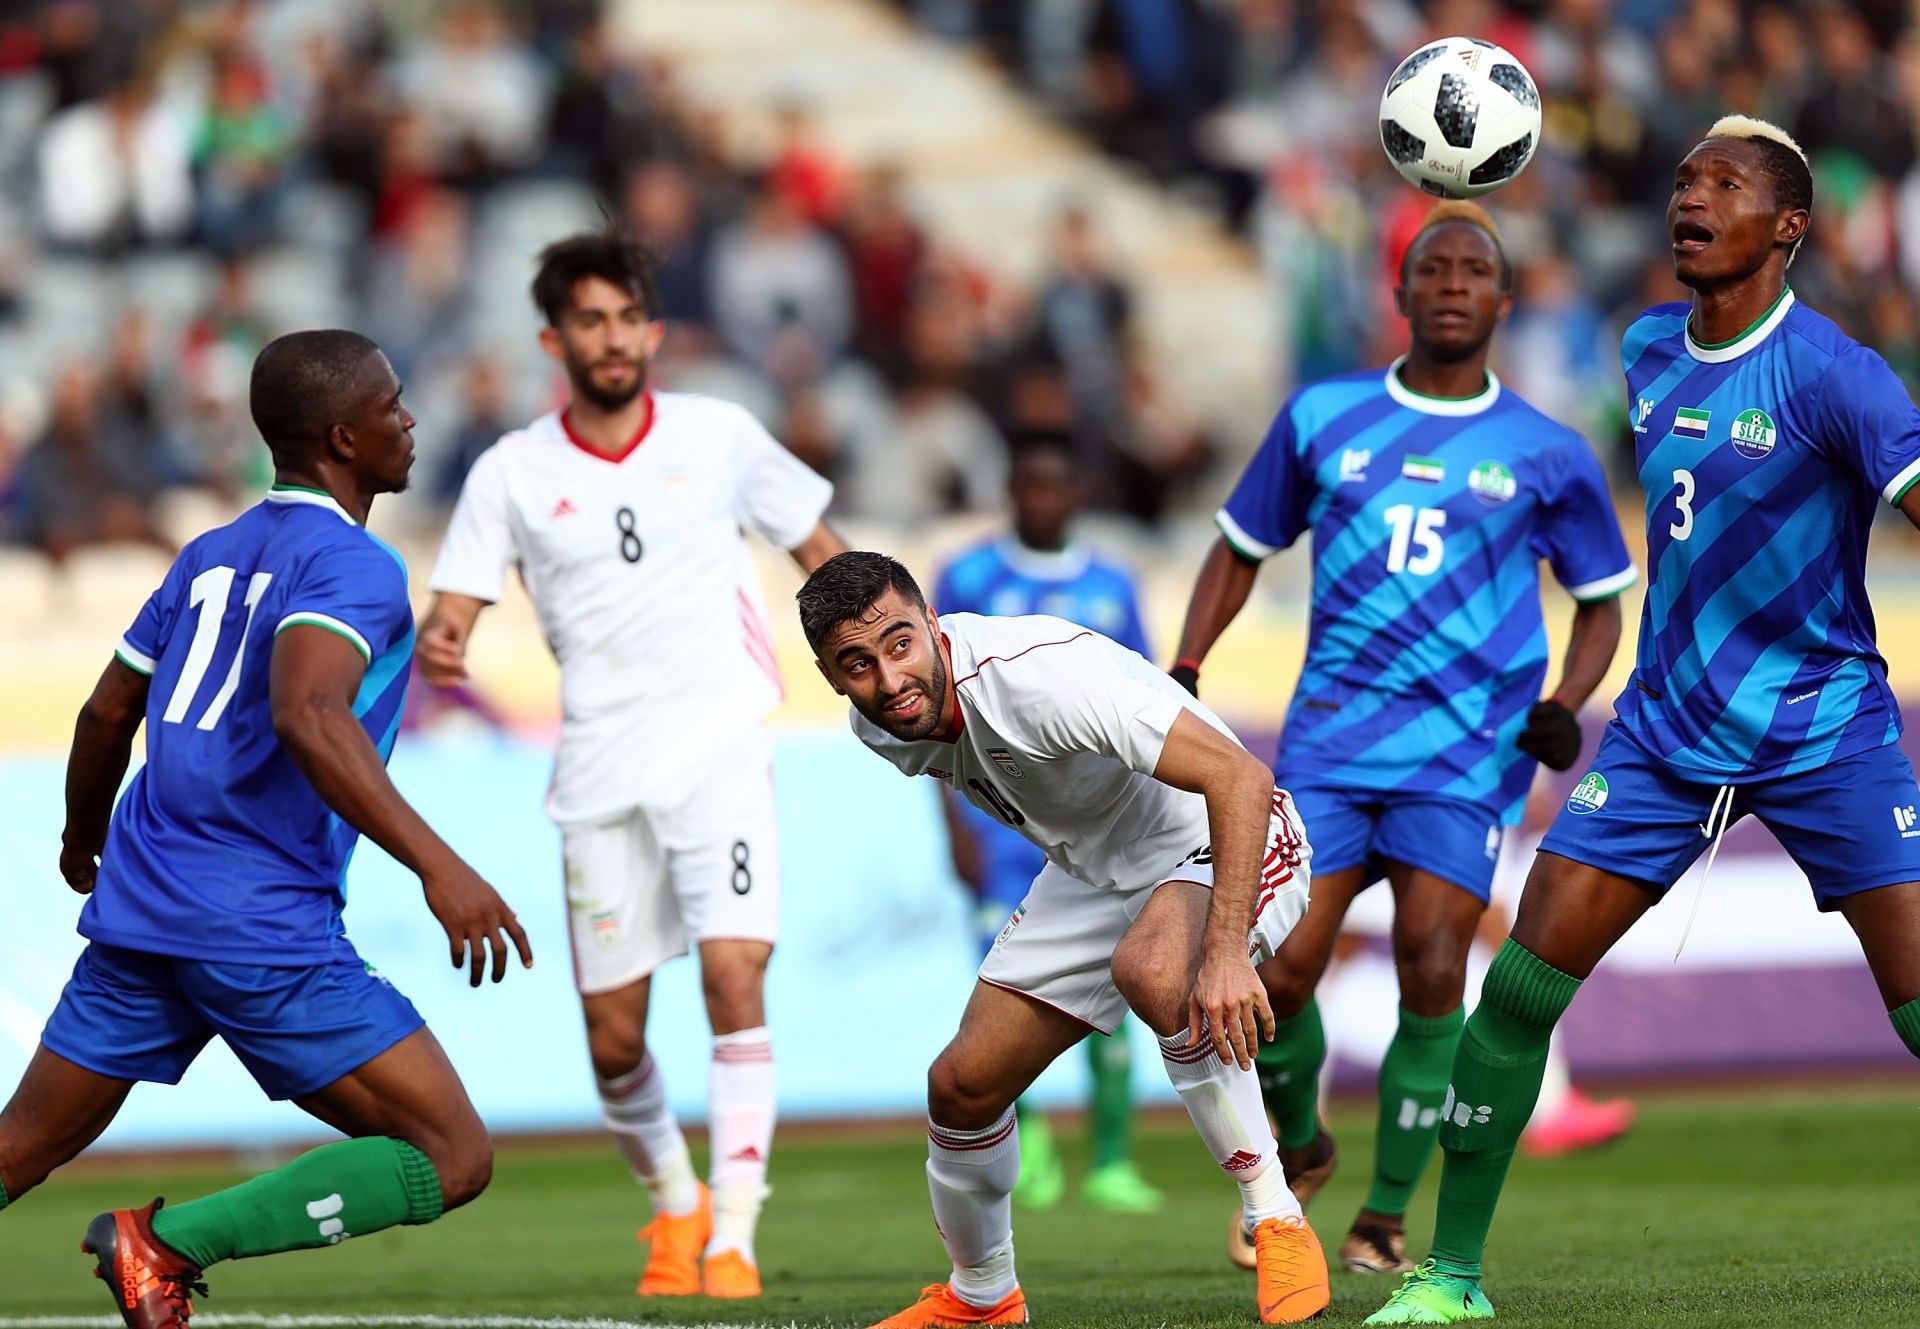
[419,234,843,1296]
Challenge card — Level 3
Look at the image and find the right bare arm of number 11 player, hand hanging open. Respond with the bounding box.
[269,624,534,987]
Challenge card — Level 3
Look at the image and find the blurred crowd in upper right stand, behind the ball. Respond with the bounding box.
[895,0,1920,478]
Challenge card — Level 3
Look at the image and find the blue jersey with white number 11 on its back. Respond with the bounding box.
[81,488,413,964]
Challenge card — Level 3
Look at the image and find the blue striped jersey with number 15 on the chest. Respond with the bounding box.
[1217,365,1634,824]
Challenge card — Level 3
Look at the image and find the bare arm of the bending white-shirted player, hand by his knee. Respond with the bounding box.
[1154,711,1273,1070]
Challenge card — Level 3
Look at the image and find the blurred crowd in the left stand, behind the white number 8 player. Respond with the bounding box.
[0,0,1210,559]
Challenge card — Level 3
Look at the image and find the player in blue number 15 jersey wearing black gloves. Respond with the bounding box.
[1175,204,1634,1273]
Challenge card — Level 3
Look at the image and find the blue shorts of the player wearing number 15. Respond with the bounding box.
[1275,774,1500,903]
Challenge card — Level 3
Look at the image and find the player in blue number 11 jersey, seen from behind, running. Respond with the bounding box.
[0,332,532,1329]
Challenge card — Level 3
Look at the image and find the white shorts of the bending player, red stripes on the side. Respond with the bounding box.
[979,789,1313,1033]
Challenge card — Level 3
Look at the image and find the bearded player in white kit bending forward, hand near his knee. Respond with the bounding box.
[799,553,1327,1329]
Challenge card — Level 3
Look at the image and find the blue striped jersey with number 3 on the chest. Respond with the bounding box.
[1617,292,1920,784]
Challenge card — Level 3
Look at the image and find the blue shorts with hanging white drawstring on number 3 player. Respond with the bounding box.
[1540,720,1920,910]
